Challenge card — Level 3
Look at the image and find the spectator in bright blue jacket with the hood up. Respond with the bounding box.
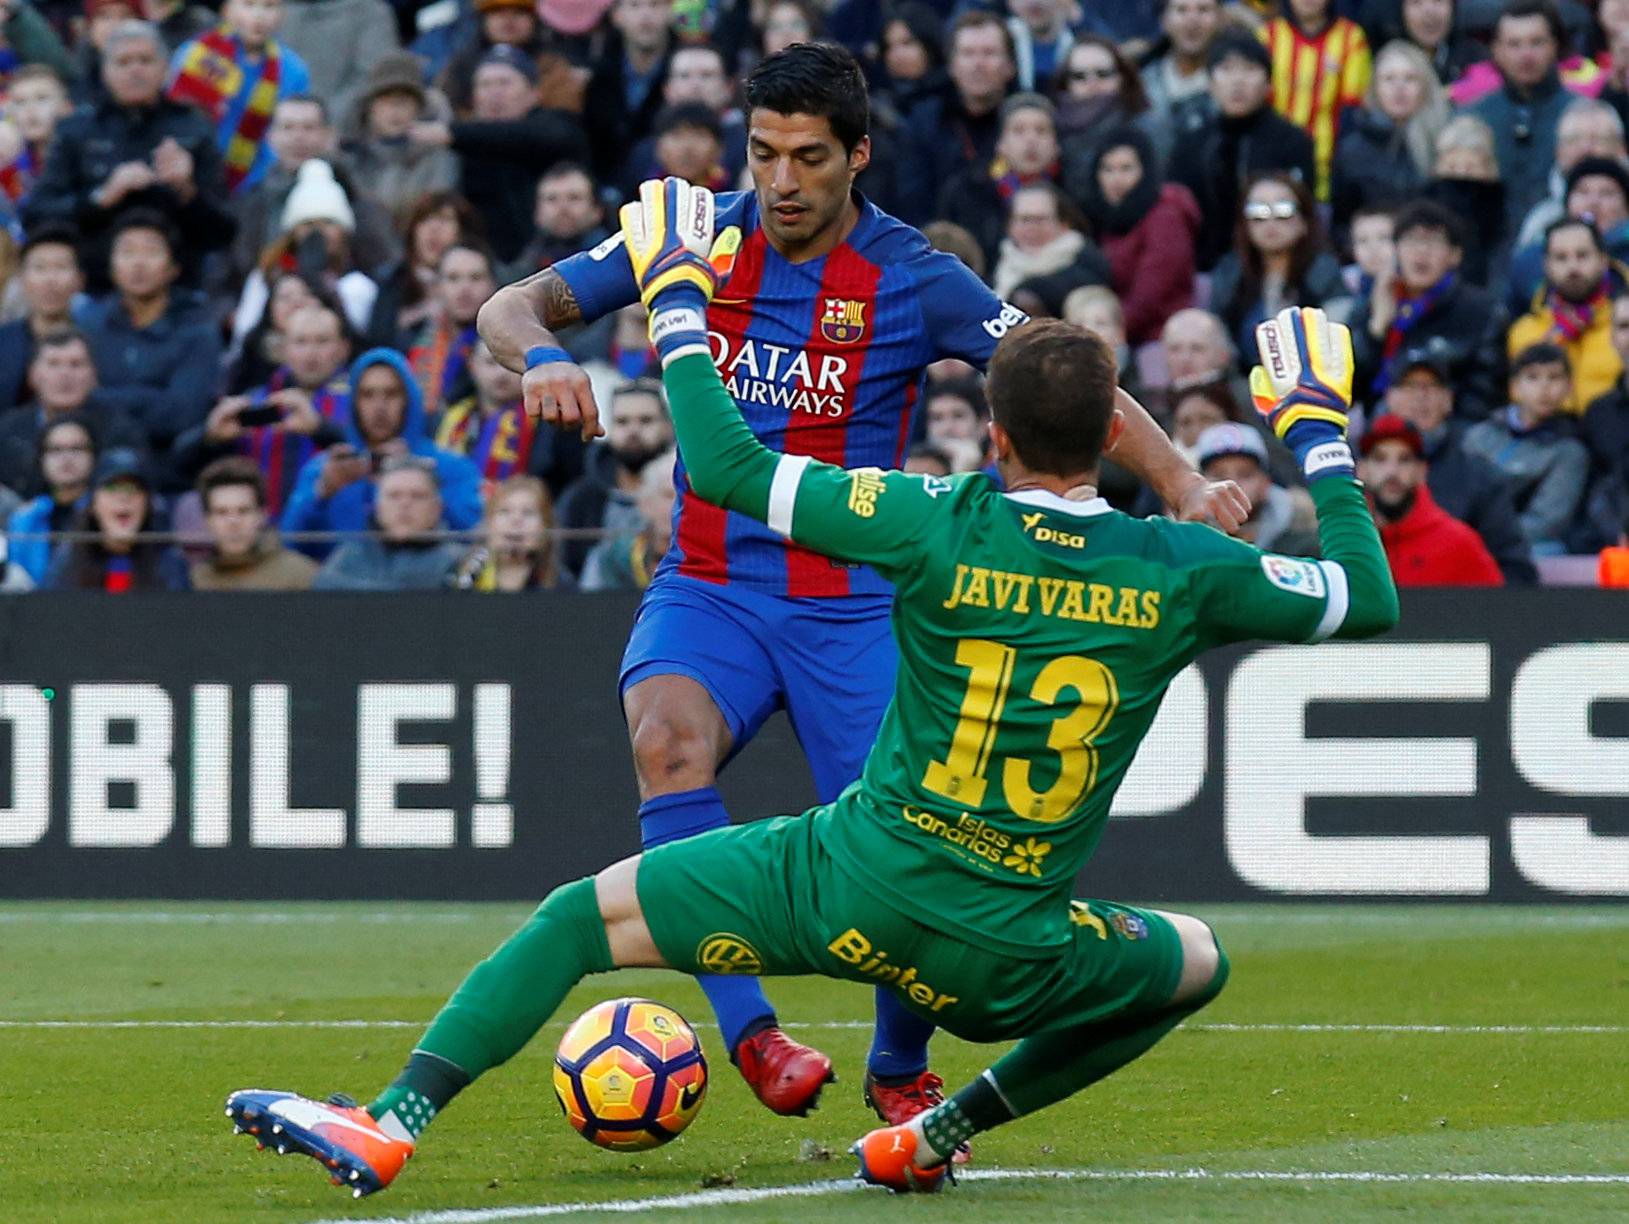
[282,349,481,554]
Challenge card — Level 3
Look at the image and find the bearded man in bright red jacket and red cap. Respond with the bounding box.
[1357,412,1505,587]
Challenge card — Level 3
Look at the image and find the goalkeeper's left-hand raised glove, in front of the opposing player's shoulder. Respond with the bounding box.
[619,178,741,365]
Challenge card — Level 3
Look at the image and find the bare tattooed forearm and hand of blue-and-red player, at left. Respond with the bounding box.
[476,267,604,442]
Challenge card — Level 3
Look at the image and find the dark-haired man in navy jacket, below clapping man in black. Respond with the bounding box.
[85,209,220,482]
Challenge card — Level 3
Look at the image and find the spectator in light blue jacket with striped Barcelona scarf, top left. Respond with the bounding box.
[168,0,311,196]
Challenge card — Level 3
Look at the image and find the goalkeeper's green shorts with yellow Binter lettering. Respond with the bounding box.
[639,808,1183,1041]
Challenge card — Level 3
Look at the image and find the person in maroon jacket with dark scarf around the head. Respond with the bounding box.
[1065,127,1199,347]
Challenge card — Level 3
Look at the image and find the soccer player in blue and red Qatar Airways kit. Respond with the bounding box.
[475,44,1248,1123]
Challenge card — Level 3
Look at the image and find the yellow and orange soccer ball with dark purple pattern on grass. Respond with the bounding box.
[554,999,707,1152]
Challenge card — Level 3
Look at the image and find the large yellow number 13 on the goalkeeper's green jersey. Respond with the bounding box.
[922,637,1119,825]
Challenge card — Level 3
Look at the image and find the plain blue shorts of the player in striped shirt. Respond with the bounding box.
[619,575,898,804]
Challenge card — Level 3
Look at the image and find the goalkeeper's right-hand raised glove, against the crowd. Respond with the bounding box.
[1249,306,1357,481]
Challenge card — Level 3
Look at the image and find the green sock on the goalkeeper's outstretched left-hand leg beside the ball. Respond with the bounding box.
[368,878,613,1138]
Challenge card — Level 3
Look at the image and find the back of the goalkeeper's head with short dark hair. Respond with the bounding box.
[986,319,1117,476]
